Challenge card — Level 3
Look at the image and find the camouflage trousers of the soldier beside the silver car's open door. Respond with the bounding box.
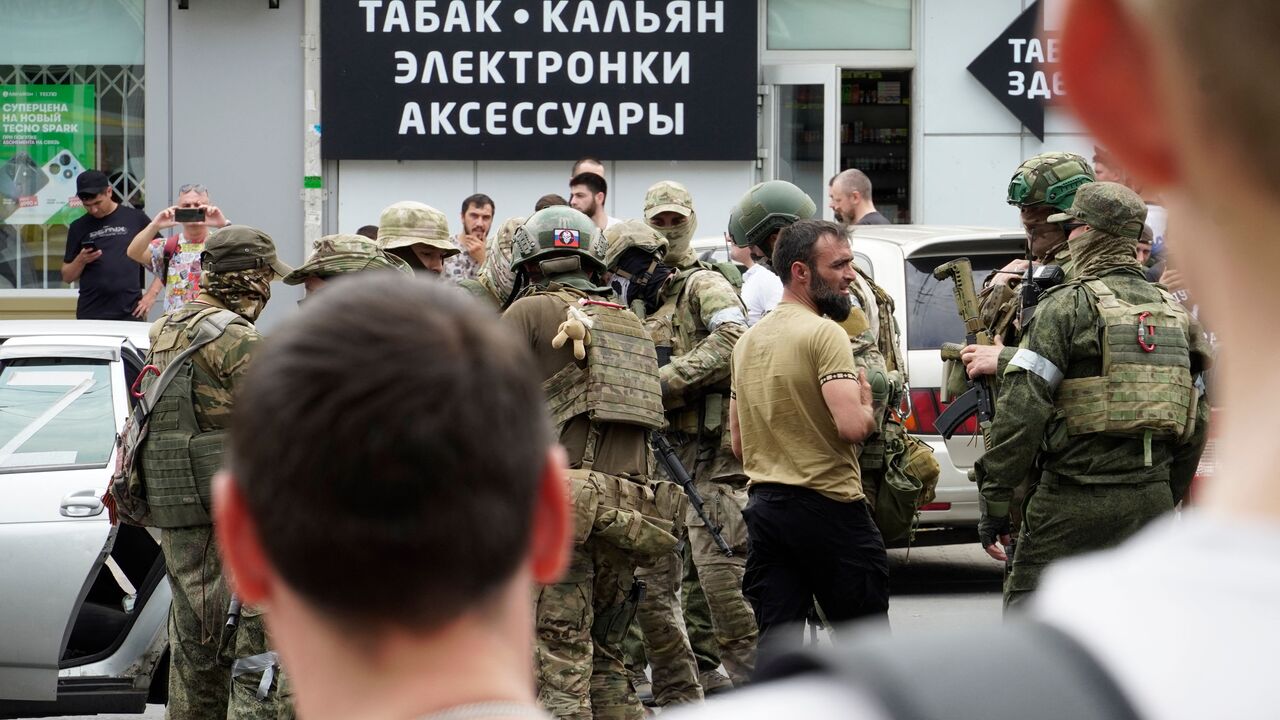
[160,525,293,720]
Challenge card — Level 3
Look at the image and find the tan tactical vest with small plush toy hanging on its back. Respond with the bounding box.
[543,290,663,435]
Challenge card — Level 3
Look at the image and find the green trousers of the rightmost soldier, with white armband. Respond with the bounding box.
[1005,480,1174,611]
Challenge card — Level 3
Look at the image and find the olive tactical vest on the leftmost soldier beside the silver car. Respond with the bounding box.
[136,307,252,528]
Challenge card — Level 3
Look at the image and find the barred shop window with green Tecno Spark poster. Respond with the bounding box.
[0,0,146,290]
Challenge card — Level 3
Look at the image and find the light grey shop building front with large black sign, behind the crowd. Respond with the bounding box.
[0,0,1092,325]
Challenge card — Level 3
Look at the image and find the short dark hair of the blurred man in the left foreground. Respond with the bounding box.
[227,272,554,633]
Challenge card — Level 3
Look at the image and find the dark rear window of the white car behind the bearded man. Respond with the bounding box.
[906,255,1014,350]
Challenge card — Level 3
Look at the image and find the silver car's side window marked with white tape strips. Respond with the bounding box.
[0,357,115,473]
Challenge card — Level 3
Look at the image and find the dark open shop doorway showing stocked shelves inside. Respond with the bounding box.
[840,69,911,223]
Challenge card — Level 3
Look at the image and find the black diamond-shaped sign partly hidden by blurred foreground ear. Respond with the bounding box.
[969,0,1064,140]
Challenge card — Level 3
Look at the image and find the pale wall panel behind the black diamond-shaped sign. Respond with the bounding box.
[914,0,1093,227]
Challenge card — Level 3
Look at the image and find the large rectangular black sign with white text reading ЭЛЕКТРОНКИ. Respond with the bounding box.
[321,0,756,160]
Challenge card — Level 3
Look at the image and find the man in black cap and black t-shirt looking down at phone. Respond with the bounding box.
[63,170,150,320]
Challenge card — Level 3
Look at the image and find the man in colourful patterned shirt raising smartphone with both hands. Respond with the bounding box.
[128,183,229,311]
